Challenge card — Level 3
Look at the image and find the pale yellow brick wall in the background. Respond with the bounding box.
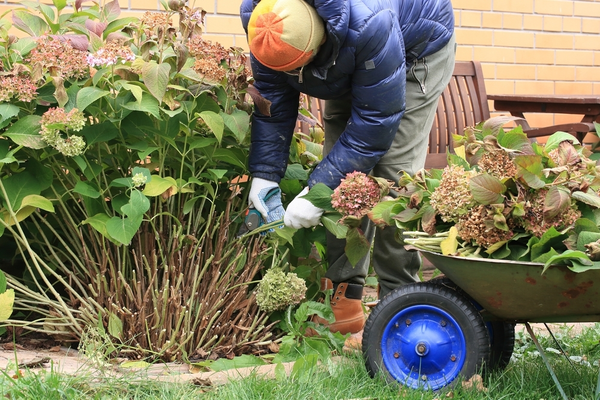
[7,0,600,126]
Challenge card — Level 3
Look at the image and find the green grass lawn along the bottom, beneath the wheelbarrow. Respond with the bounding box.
[0,324,600,400]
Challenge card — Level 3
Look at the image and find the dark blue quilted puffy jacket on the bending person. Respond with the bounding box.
[240,0,454,188]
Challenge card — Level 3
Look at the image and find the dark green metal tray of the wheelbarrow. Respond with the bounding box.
[414,247,600,322]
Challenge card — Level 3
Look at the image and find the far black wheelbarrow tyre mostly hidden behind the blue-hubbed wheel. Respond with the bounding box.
[429,276,515,371]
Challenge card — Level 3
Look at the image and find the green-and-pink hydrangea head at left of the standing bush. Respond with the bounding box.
[40,108,85,157]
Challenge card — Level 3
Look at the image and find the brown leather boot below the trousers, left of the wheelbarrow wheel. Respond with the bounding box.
[313,278,365,335]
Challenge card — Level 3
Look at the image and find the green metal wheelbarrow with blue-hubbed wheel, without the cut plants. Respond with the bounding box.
[362,250,600,399]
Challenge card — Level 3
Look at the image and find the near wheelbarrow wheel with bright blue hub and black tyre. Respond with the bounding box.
[362,282,490,390]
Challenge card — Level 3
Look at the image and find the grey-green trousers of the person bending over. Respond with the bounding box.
[323,37,456,298]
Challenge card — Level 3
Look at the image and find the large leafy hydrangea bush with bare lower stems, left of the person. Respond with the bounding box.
[0,0,284,360]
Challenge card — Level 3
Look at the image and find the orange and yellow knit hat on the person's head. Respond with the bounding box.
[248,0,325,71]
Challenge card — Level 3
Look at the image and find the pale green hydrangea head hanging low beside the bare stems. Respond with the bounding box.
[256,268,306,313]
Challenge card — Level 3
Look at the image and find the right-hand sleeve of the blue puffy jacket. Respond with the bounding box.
[309,10,406,188]
